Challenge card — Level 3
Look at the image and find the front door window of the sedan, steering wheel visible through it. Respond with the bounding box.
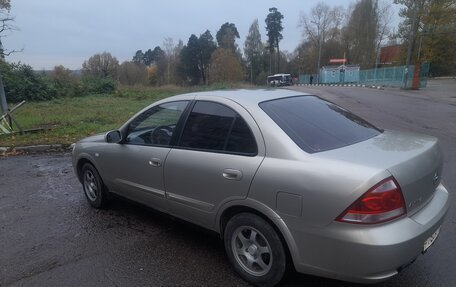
[126,101,188,146]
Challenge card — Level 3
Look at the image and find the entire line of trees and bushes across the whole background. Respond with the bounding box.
[0,0,456,104]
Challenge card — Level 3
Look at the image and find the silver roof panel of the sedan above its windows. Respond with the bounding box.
[168,89,310,105]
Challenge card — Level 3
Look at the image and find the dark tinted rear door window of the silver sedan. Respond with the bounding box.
[179,101,257,155]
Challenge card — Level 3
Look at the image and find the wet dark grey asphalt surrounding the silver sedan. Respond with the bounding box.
[0,80,456,286]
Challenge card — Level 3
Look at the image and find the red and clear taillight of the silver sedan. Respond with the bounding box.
[336,177,405,224]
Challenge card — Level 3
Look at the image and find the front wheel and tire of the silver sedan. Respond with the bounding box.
[81,163,108,209]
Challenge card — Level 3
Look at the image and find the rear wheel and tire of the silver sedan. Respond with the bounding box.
[224,213,287,287]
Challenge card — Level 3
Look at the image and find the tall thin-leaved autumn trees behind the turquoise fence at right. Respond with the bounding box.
[295,0,456,76]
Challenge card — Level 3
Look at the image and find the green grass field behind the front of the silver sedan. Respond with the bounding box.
[0,84,251,147]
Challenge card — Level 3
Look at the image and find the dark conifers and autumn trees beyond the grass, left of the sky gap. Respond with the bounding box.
[82,7,288,86]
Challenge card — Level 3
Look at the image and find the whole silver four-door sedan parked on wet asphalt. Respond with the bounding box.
[73,90,449,286]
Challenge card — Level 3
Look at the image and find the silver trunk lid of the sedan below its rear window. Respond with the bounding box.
[320,131,443,215]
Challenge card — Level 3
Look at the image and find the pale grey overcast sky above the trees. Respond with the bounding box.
[6,0,400,70]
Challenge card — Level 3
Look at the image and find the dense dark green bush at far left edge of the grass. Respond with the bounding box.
[0,61,56,103]
